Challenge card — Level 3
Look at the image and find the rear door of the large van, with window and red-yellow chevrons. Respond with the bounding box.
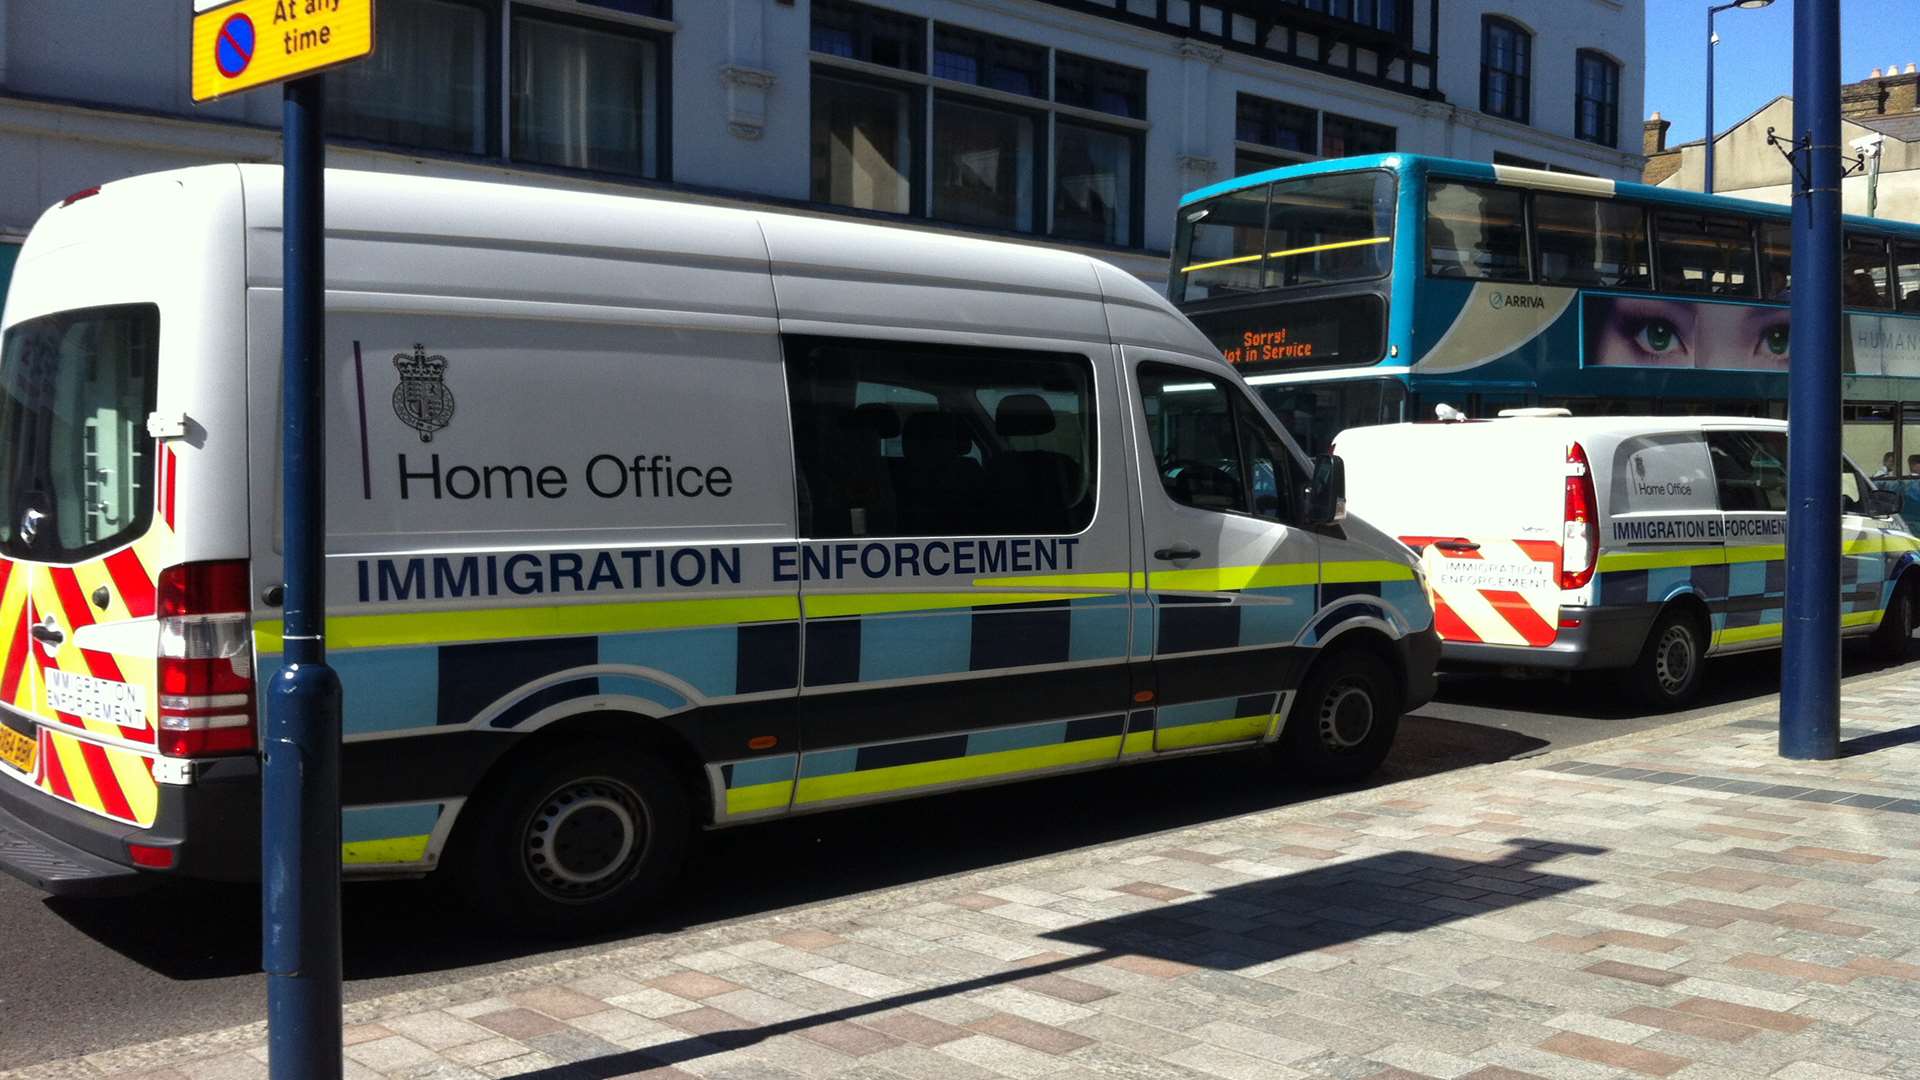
[0,304,171,826]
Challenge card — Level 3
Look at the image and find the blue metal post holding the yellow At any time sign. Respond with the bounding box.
[261,77,342,1080]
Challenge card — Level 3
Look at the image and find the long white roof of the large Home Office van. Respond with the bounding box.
[194,165,1225,353]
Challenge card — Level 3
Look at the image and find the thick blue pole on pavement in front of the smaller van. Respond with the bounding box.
[1780,0,1841,761]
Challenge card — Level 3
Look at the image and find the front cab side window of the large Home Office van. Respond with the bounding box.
[1140,363,1300,521]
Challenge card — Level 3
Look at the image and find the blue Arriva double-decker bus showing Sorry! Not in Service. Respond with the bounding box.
[1169,154,1920,495]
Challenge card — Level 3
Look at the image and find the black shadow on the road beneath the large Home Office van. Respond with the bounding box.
[46,717,1546,982]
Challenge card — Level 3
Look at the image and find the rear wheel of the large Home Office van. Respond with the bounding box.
[455,740,693,936]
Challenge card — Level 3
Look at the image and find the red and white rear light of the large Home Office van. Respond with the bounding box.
[156,559,257,757]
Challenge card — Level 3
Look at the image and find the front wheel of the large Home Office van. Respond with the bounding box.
[1273,650,1405,784]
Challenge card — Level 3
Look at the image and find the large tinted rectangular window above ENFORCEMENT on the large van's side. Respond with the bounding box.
[785,336,1098,538]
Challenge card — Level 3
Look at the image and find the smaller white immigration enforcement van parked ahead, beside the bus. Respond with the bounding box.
[1336,409,1920,707]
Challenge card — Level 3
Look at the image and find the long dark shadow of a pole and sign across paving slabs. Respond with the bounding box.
[499,838,1605,1080]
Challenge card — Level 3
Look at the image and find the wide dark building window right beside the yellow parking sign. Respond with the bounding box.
[336,0,670,179]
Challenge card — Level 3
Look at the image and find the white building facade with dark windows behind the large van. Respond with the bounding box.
[0,0,1644,295]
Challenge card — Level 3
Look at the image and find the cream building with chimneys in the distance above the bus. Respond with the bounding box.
[1642,63,1920,221]
